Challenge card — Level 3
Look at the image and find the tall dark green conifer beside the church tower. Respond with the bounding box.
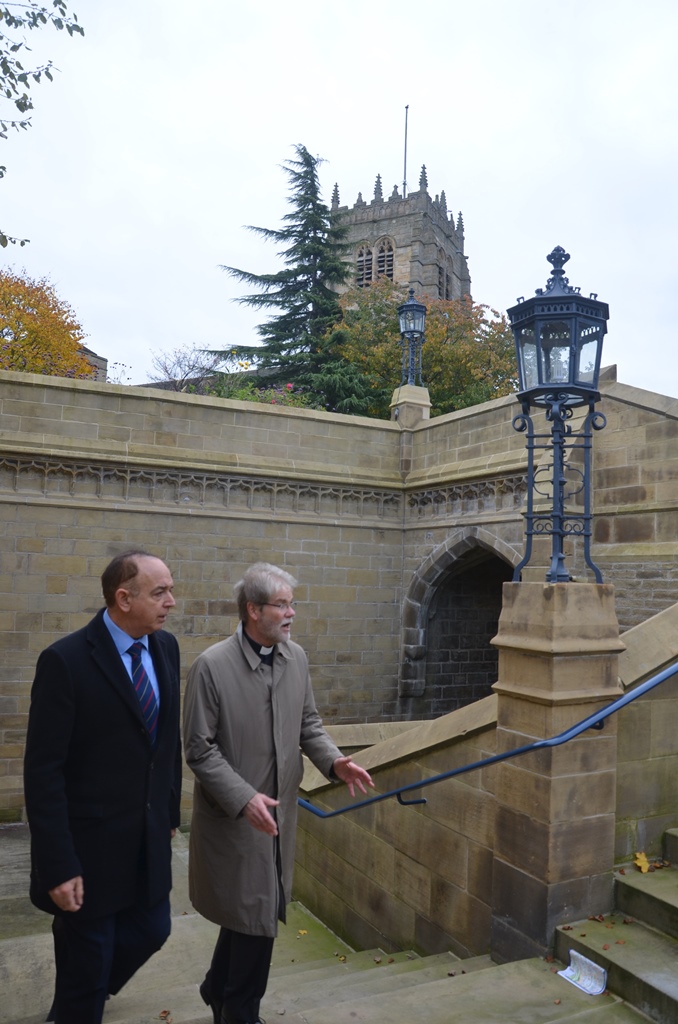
[218,144,354,408]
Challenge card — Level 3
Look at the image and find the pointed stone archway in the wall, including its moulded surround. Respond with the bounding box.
[398,526,520,718]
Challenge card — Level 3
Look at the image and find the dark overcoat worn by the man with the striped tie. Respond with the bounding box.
[25,610,181,919]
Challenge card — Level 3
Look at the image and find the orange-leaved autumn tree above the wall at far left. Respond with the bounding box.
[0,270,96,377]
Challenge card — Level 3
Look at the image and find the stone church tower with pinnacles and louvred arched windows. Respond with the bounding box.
[332,167,471,299]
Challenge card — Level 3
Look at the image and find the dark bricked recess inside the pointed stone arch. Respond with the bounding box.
[426,549,513,717]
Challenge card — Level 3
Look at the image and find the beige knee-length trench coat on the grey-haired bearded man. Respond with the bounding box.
[183,626,341,936]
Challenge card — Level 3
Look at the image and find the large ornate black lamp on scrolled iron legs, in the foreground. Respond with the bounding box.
[507,246,609,583]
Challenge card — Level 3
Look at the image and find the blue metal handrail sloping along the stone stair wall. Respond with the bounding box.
[297,662,678,818]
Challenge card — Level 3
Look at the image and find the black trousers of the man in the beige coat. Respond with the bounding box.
[205,928,274,1024]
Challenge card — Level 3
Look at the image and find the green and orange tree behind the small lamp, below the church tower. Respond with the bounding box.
[326,278,516,418]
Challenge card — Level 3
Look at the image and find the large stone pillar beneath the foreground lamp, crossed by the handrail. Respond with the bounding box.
[492,583,624,962]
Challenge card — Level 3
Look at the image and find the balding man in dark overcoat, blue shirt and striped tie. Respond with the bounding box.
[25,551,181,1024]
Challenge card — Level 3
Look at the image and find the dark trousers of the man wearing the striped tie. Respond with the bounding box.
[52,897,171,1024]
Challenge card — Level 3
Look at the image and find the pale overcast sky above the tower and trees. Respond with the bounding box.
[0,0,678,397]
